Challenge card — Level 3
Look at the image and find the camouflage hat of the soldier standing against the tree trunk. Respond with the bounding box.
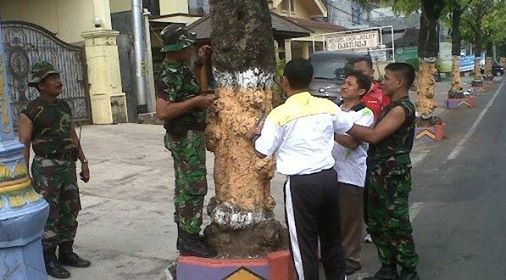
[160,24,197,52]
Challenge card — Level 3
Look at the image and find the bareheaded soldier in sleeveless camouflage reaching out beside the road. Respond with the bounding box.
[348,63,419,280]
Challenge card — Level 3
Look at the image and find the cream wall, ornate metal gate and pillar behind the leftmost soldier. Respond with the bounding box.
[0,0,127,124]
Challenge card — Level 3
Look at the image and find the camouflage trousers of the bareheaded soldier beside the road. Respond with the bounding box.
[366,168,419,267]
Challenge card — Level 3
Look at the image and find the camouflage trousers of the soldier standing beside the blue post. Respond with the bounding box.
[32,156,81,248]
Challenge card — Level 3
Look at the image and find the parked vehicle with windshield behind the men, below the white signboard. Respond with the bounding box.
[309,51,368,102]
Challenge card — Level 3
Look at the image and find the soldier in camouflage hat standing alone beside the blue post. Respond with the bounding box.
[19,61,90,278]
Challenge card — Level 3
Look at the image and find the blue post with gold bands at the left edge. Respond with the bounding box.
[0,21,49,280]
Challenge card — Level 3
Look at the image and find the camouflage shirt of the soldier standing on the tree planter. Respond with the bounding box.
[155,61,206,124]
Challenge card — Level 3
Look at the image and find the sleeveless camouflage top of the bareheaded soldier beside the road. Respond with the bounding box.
[368,97,415,170]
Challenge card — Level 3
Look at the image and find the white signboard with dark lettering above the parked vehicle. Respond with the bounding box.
[326,31,379,51]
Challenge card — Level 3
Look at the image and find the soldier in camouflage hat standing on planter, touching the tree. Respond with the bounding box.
[156,25,217,257]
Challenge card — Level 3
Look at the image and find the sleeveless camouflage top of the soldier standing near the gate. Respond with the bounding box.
[21,97,75,158]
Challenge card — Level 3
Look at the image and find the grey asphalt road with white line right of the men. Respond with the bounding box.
[354,78,506,280]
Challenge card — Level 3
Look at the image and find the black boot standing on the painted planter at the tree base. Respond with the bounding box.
[176,228,218,258]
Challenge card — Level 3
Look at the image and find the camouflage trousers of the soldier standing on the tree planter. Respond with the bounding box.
[165,130,207,234]
